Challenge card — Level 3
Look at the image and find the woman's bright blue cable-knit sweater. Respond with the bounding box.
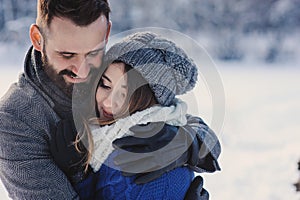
[75,126,194,200]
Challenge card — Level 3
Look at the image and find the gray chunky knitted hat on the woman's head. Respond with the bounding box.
[105,32,198,106]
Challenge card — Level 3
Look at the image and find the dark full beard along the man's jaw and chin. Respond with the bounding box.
[42,48,74,98]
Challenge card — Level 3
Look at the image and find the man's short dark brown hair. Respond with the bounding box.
[37,0,110,27]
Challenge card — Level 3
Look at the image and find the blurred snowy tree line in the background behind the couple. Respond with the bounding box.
[0,0,300,62]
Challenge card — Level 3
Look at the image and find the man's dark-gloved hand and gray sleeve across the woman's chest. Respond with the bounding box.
[113,116,221,183]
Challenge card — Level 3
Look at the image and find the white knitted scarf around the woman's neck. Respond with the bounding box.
[89,99,187,172]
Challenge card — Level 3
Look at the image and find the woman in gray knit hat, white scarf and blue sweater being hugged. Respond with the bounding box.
[51,32,218,199]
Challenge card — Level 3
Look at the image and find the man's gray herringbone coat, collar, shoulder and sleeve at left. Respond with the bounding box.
[0,47,78,200]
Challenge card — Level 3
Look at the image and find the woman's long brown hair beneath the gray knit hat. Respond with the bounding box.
[75,60,157,170]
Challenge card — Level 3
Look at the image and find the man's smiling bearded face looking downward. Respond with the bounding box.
[42,16,109,94]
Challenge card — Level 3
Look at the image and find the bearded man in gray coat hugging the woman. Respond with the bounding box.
[0,0,220,199]
